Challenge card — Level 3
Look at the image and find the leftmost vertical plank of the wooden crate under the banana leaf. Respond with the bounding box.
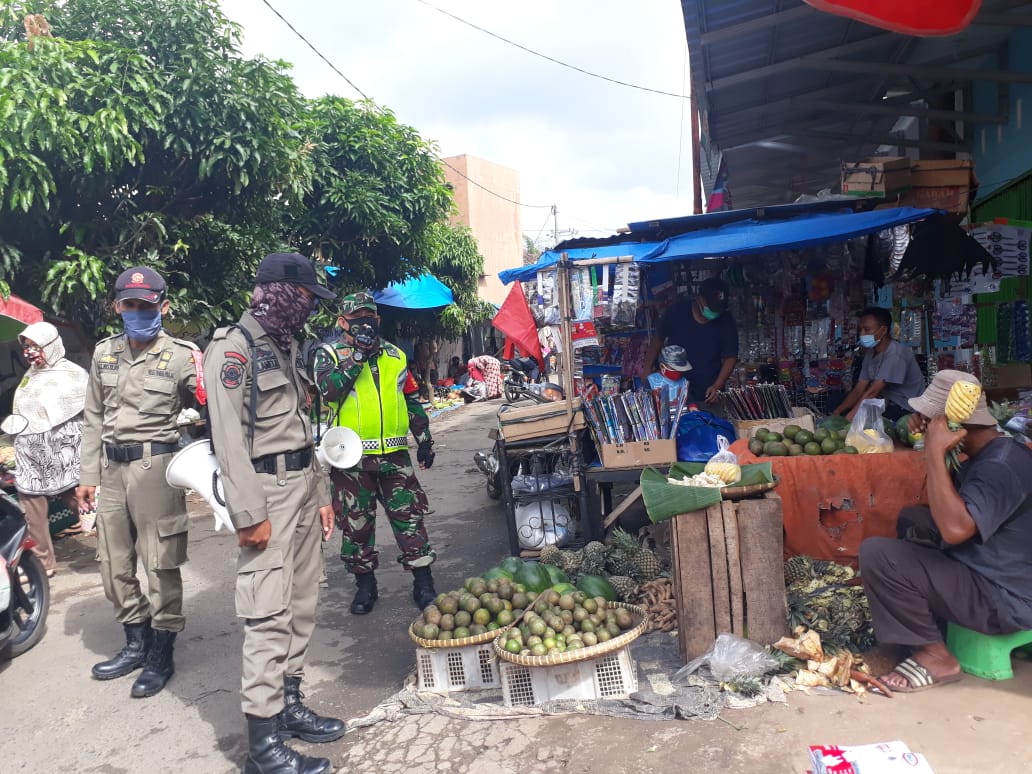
[670,511,716,664]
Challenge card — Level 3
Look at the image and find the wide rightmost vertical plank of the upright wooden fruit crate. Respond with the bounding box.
[738,492,788,644]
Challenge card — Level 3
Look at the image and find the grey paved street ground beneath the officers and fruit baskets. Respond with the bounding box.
[6,404,1032,774]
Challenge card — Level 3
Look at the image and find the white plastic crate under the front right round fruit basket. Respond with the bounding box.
[501,647,638,707]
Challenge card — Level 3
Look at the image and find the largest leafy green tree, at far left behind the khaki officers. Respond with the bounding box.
[0,0,312,330]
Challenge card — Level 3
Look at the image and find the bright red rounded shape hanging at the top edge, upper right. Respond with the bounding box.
[804,0,981,36]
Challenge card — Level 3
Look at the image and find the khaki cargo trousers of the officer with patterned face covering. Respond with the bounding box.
[236,458,328,717]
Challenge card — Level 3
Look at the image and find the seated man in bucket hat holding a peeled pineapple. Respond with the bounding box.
[860,370,1032,692]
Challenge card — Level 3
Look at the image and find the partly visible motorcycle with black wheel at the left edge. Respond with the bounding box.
[0,478,51,659]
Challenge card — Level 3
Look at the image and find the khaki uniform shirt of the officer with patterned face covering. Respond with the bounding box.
[204,312,330,528]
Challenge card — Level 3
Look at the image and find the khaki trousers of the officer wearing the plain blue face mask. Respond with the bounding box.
[97,454,189,632]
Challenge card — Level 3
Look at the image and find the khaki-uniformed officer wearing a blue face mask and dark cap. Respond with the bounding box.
[75,266,200,699]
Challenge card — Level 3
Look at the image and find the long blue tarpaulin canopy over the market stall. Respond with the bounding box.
[498,207,936,283]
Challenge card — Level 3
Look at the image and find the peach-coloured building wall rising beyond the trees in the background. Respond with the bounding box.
[444,155,523,305]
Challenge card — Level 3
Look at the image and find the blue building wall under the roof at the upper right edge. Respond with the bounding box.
[971,27,1032,199]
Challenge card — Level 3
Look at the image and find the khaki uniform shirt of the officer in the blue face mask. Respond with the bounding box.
[79,331,197,486]
